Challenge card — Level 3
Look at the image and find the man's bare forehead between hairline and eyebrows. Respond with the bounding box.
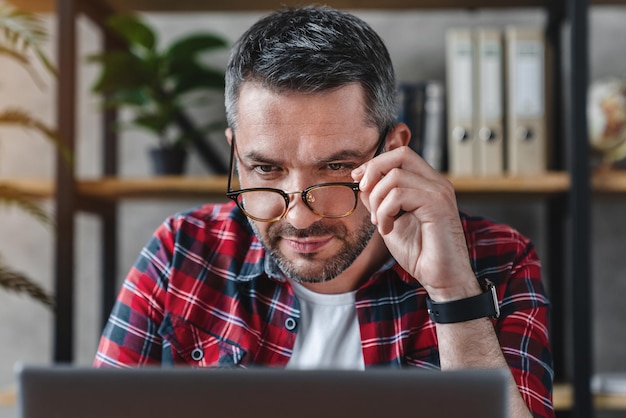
[236,82,377,153]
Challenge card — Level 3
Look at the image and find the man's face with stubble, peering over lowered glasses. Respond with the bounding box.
[235,83,379,283]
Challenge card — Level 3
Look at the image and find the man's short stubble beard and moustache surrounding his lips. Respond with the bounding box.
[250,214,376,283]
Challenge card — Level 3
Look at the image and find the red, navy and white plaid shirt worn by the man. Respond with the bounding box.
[94,203,554,417]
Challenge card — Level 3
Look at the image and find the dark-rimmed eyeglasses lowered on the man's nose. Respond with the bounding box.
[226,128,389,222]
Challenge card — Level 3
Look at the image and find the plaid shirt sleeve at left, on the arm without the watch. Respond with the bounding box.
[94,218,174,368]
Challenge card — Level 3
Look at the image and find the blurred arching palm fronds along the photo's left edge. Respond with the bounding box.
[0,2,60,307]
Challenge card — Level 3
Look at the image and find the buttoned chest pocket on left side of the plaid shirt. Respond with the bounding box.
[161,315,246,367]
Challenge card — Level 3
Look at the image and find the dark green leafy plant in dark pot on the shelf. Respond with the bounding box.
[90,15,227,174]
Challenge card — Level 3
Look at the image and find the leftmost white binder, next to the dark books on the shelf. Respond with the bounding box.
[446,29,475,176]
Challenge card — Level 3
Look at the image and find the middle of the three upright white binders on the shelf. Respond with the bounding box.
[474,28,504,176]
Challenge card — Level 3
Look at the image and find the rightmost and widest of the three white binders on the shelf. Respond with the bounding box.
[505,27,547,175]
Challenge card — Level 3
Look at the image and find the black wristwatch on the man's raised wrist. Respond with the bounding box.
[426,280,500,324]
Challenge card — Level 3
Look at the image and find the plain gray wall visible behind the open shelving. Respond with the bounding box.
[0,8,626,417]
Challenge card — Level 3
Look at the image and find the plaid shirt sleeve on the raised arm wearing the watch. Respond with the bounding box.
[470,225,554,417]
